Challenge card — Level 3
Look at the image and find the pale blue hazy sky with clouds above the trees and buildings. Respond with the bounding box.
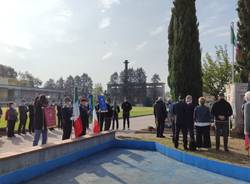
[0,0,237,89]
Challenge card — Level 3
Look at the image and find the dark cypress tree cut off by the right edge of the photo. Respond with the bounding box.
[237,0,250,82]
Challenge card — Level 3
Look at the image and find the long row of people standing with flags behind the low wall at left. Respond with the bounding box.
[0,95,132,146]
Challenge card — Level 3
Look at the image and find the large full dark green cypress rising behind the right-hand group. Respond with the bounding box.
[168,0,202,101]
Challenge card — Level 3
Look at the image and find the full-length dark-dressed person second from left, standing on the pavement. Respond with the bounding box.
[18,100,29,134]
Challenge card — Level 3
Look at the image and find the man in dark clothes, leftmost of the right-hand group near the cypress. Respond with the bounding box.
[154,97,167,138]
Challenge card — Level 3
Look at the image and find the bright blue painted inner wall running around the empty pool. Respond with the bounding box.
[0,140,250,184]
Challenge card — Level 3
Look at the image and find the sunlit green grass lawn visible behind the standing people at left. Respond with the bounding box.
[0,107,153,129]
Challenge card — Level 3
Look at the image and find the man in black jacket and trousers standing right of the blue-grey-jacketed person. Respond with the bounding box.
[211,94,233,152]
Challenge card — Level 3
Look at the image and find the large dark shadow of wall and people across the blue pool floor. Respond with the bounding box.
[24,149,145,184]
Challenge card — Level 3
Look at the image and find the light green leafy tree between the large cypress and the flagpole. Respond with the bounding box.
[203,46,232,97]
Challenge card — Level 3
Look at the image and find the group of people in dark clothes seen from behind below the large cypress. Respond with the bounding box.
[154,94,233,151]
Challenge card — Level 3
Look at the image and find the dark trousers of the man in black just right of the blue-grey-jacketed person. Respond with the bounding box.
[215,122,229,150]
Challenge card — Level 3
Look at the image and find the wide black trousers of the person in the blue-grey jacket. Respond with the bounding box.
[195,126,211,148]
